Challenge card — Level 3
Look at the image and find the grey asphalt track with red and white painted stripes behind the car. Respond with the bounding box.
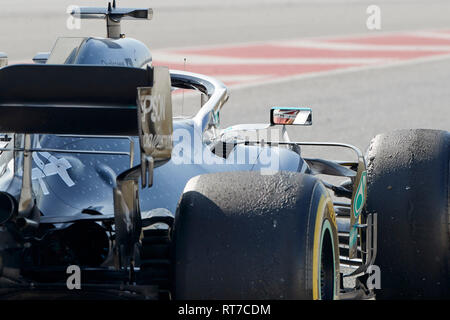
[0,0,450,298]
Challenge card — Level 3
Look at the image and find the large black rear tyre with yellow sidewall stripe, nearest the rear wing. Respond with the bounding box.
[173,172,339,300]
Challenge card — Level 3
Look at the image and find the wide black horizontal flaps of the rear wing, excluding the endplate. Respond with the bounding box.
[0,65,154,136]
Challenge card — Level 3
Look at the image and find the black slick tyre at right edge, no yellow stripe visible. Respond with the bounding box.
[366,130,450,299]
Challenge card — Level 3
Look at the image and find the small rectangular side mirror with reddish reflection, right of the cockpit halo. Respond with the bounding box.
[270,107,312,126]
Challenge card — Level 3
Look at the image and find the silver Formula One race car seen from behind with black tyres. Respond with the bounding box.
[0,3,450,299]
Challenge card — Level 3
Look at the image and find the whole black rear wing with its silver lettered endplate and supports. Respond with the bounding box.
[0,64,173,272]
